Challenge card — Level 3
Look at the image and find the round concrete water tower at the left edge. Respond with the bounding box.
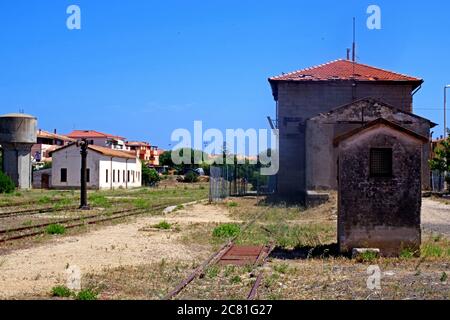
[0,113,37,189]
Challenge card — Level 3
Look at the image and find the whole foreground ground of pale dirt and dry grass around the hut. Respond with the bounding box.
[0,198,450,299]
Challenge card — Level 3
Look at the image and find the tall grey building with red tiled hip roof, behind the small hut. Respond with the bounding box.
[269,60,433,200]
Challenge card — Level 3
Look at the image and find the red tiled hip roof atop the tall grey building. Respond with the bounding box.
[269,59,423,83]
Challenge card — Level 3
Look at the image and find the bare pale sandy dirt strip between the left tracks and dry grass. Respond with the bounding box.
[0,204,232,299]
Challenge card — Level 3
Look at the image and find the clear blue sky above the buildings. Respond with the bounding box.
[0,0,450,148]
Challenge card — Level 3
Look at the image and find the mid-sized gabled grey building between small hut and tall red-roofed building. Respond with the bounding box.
[305,98,436,190]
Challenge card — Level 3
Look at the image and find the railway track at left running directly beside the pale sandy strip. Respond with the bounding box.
[0,204,167,243]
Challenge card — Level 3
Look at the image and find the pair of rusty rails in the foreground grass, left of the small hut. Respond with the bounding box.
[163,211,275,300]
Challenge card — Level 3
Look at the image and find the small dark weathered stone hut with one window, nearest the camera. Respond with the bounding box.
[334,118,428,256]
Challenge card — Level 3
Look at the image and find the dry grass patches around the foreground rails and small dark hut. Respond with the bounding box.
[59,195,450,299]
